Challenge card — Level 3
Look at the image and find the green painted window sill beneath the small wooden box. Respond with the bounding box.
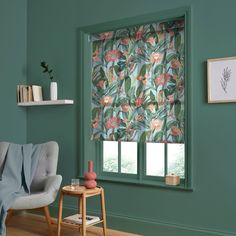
[80,176,193,192]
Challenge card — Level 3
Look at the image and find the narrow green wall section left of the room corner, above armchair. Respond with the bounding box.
[0,0,27,143]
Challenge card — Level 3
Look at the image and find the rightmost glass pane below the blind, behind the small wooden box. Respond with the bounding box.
[167,144,184,178]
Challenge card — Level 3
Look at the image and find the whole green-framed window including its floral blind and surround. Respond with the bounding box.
[78,9,191,188]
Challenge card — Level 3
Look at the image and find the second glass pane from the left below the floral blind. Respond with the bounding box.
[121,142,137,174]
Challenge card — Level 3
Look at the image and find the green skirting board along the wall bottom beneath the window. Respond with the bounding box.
[50,206,236,236]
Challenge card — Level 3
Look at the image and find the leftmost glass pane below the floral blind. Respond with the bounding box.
[103,141,118,172]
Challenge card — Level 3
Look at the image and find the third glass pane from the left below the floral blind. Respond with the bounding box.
[146,143,165,176]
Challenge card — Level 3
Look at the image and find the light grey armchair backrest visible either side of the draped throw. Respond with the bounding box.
[0,141,59,192]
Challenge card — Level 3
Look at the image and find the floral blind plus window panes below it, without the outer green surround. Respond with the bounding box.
[91,18,188,185]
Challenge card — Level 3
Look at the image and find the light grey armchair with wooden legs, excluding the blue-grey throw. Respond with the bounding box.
[0,141,62,236]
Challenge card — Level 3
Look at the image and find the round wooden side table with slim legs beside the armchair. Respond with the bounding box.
[57,185,106,236]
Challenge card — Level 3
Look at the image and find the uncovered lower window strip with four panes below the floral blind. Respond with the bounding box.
[102,141,185,182]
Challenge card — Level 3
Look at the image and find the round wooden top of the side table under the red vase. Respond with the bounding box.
[62,185,102,195]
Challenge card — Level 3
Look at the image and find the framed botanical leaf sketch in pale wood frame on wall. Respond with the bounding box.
[207,57,236,103]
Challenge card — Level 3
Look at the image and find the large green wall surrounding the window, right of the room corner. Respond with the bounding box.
[27,0,236,236]
